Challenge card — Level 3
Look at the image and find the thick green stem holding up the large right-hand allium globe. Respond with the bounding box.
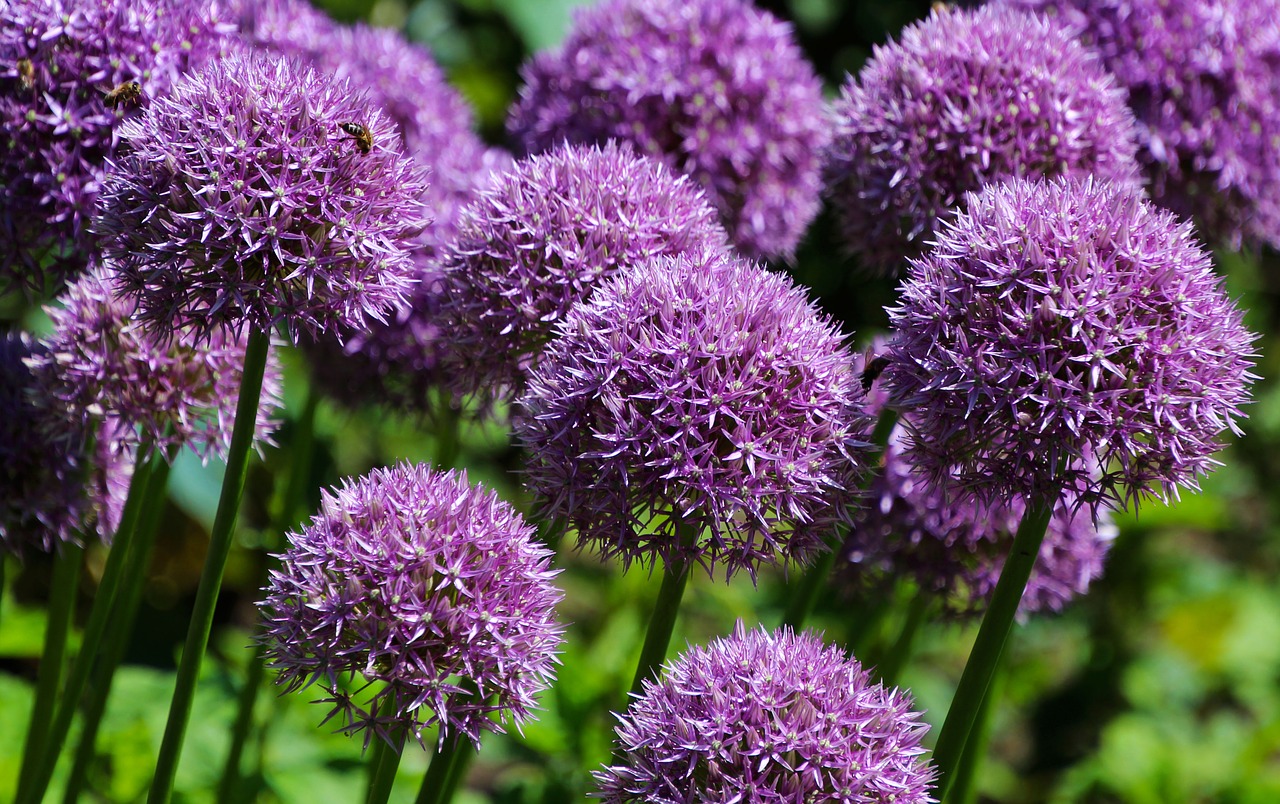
[933,501,1053,800]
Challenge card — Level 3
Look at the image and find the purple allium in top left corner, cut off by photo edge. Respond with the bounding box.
[0,0,229,292]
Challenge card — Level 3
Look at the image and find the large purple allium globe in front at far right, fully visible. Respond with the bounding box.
[884,179,1254,506]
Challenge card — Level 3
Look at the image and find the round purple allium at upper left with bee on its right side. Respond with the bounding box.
[96,47,425,337]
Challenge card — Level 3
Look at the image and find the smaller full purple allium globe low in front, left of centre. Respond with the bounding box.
[260,463,562,745]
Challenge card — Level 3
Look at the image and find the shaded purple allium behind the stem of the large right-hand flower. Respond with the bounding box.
[842,348,1116,617]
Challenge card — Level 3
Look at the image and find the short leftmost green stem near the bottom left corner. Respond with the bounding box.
[18,544,84,791]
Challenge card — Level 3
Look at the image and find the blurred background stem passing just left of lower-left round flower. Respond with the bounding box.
[218,385,319,804]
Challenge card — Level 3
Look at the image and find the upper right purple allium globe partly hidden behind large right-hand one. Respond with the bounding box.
[827,6,1138,274]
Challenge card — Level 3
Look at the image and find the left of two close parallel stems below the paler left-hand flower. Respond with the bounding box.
[15,444,164,804]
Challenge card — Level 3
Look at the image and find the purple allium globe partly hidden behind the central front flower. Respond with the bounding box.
[444,142,728,396]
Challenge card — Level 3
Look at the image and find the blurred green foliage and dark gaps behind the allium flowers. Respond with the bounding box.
[0,0,1280,804]
